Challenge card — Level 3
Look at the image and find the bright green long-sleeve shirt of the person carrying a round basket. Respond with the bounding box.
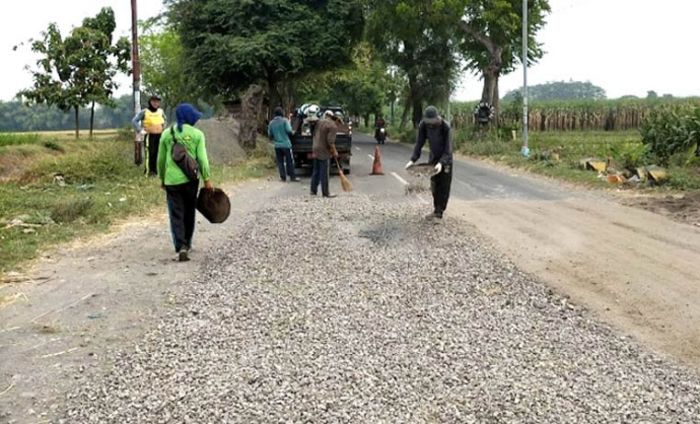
[158,124,211,185]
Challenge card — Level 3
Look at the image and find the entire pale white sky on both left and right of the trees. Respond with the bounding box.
[0,0,700,101]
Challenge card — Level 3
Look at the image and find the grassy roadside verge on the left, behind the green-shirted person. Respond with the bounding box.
[0,132,271,274]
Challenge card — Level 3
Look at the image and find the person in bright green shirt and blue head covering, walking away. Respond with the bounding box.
[158,103,214,262]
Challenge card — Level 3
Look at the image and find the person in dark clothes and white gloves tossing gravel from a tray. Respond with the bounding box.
[406,106,452,219]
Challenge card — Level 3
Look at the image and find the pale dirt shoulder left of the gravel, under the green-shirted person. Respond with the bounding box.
[0,180,283,423]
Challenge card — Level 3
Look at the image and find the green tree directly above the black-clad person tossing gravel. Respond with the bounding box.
[367,0,469,126]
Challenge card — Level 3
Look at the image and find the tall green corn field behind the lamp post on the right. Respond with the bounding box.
[452,98,700,131]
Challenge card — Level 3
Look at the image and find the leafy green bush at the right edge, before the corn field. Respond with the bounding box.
[640,104,700,165]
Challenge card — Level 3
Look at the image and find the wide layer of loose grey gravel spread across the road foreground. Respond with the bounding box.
[61,194,700,424]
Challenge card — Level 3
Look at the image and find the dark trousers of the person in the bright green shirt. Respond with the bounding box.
[165,180,199,252]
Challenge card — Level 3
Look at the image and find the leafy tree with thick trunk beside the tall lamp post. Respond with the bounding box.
[459,0,550,115]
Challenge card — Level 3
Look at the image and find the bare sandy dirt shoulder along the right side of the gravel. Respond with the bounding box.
[449,195,700,370]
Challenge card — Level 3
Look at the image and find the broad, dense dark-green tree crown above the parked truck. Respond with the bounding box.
[167,0,364,107]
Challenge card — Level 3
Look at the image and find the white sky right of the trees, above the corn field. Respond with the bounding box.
[453,0,700,100]
